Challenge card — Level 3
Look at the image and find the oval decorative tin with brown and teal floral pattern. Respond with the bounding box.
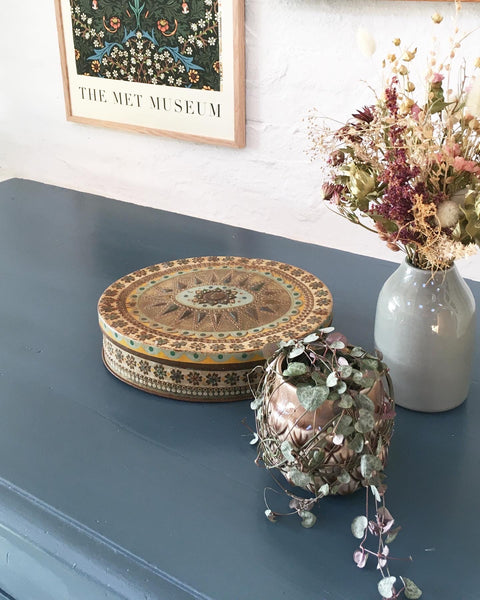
[98,256,333,402]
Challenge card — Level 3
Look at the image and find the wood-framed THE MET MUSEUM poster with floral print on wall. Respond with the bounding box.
[55,0,245,147]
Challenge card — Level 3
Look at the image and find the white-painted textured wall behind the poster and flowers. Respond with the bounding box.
[0,0,480,280]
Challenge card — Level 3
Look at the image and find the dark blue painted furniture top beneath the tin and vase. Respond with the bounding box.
[0,180,480,600]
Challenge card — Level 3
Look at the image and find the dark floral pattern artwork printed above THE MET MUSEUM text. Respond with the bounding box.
[70,0,221,91]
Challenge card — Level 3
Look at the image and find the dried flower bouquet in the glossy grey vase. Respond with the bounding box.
[309,5,480,270]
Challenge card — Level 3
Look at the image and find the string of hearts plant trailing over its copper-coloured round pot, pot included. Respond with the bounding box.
[251,327,422,600]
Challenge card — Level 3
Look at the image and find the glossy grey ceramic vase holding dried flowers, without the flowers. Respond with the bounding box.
[375,261,475,412]
